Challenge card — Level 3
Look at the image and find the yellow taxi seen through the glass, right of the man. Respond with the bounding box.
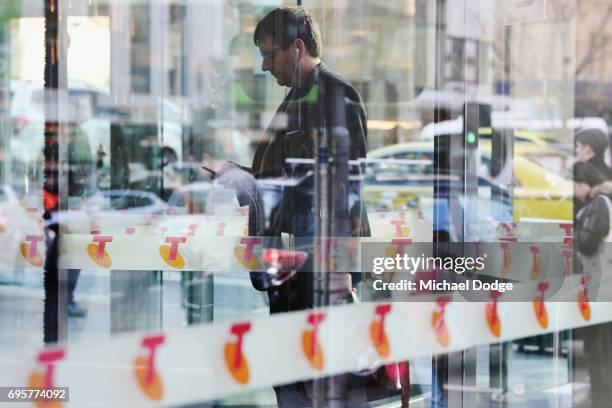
[364,140,573,222]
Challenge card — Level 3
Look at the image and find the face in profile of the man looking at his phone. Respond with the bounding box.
[259,37,298,87]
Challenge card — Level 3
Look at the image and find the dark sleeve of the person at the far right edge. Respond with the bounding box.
[576,197,610,256]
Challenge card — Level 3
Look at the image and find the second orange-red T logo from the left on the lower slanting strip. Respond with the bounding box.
[134,334,165,401]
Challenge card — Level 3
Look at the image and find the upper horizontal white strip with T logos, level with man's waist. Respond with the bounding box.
[55,232,573,282]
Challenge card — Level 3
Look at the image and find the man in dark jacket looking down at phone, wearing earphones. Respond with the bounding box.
[217,7,370,406]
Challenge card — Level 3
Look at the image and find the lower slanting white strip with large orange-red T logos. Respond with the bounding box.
[0,277,612,407]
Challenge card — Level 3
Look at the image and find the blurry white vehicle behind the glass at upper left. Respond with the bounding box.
[9,80,185,179]
